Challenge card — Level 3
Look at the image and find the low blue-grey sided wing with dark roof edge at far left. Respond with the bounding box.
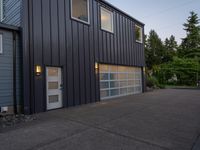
[0,23,22,112]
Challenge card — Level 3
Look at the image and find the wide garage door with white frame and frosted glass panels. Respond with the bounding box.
[99,65,142,99]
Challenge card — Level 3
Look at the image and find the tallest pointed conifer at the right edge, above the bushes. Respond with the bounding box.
[179,11,200,58]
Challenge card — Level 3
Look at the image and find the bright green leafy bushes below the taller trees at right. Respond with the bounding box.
[153,57,200,85]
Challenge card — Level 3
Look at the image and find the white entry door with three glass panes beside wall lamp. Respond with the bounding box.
[46,67,63,110]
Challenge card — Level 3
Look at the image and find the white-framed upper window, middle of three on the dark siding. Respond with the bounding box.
[101,7,113,33]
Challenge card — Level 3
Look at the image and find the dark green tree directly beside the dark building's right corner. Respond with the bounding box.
[145,30,164,69]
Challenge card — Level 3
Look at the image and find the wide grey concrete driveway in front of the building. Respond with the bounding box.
[0,89,200,150]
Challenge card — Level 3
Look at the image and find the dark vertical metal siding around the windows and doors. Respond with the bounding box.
[23,0,144,113]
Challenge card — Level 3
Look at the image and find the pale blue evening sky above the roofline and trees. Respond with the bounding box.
[107,0,200,43]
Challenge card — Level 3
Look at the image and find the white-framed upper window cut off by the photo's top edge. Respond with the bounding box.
[71,0,90,24]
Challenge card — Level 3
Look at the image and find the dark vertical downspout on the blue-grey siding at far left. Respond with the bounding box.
[13,31,17,114]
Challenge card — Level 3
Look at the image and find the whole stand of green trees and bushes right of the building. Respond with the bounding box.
[145,12,200,85]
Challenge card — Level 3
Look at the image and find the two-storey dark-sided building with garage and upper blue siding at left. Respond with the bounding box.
[0,0,145,114]
